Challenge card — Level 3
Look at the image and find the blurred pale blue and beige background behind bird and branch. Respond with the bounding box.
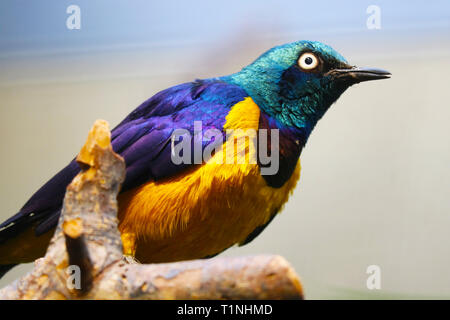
[0,0,450,299]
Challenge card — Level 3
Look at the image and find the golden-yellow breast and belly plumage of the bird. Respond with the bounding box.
[119,98,300,262]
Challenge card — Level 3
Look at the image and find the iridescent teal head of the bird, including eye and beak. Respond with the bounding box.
[224,41,390,136]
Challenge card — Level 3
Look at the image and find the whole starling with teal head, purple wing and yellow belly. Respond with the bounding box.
[0,40,391,275]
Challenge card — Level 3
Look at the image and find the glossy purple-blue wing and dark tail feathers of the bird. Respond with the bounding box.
[0,80,248,242]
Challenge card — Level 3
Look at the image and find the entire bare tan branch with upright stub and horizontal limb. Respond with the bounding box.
[0,120,303,299]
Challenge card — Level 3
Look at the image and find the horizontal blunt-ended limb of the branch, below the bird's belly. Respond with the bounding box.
[92,255,303,299]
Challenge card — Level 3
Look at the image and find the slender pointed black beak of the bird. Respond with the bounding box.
[329,67,391,84]
